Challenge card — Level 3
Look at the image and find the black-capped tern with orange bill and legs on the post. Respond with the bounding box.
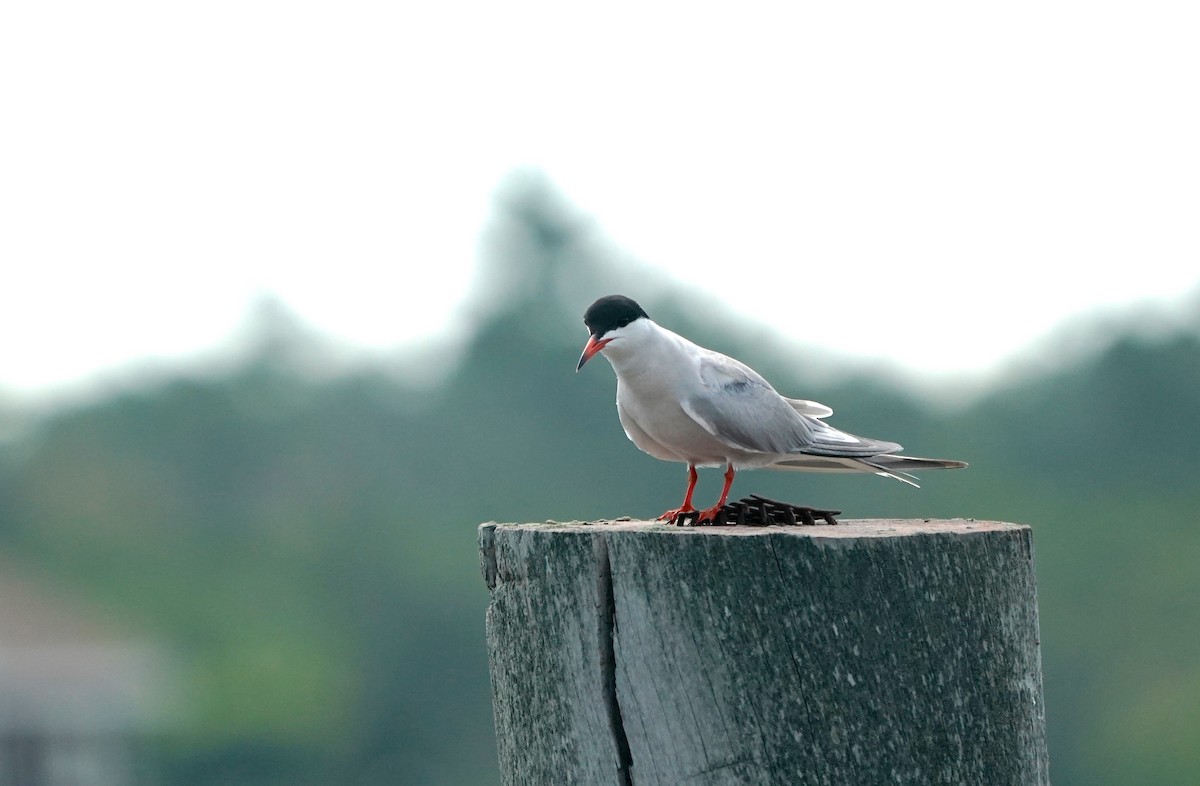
[575,295,966,523]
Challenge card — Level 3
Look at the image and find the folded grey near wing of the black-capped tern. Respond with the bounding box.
[680,353,900,456]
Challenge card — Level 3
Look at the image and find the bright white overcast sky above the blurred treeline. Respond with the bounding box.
[0,0,1200,392]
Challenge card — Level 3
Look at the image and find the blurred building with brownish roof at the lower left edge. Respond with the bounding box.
[0,560,170,786]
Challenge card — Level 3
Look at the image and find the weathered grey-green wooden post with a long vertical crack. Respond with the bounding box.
[479,520,1049,786]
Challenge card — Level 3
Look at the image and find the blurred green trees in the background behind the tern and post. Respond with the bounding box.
[0,181,1200,786]
